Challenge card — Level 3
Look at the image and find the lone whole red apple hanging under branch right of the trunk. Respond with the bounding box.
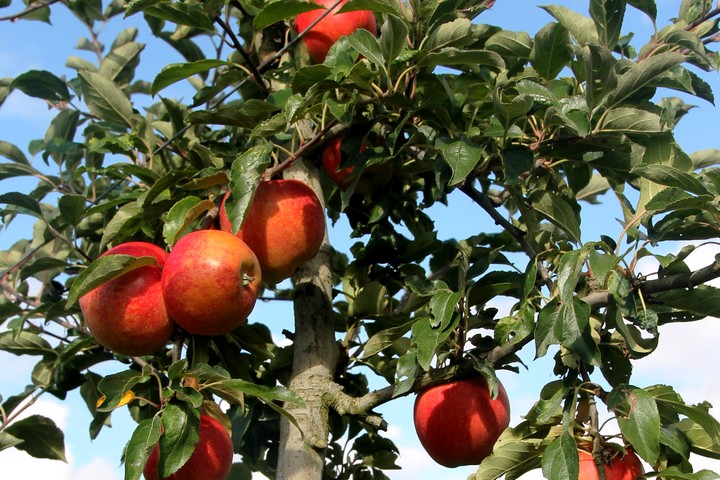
[413,377,510,468]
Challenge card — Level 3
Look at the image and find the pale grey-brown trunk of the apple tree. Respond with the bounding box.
[276,160,338,480]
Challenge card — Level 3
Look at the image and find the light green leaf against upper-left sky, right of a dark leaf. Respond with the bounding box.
[78,70,134,127]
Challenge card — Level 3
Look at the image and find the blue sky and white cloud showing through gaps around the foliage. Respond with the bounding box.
[0,0,720,480]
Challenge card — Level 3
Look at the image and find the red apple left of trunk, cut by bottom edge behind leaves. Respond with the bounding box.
[143,414,233,480]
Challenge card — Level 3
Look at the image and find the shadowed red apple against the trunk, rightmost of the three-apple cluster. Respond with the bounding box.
[220,180,325,283]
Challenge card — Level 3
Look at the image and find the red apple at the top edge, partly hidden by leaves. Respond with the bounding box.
[293,0,377,63]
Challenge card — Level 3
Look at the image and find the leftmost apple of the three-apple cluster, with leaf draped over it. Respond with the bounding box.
[80,242,175,356]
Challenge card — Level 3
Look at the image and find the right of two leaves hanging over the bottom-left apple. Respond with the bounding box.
[158,403,200,478]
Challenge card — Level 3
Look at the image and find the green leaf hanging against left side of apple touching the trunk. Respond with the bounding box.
[225,143,270,233]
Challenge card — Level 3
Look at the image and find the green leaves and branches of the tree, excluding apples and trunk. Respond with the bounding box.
[0,0,720,479]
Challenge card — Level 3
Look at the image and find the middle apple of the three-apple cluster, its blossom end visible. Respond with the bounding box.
[162,230,262,335]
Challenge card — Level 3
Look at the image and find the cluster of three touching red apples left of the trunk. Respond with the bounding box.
[80,179,325,356]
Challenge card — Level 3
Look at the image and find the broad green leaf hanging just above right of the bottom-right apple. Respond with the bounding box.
[607,385,660,465]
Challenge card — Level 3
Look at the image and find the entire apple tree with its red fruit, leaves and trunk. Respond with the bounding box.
[0,0,720,480]
